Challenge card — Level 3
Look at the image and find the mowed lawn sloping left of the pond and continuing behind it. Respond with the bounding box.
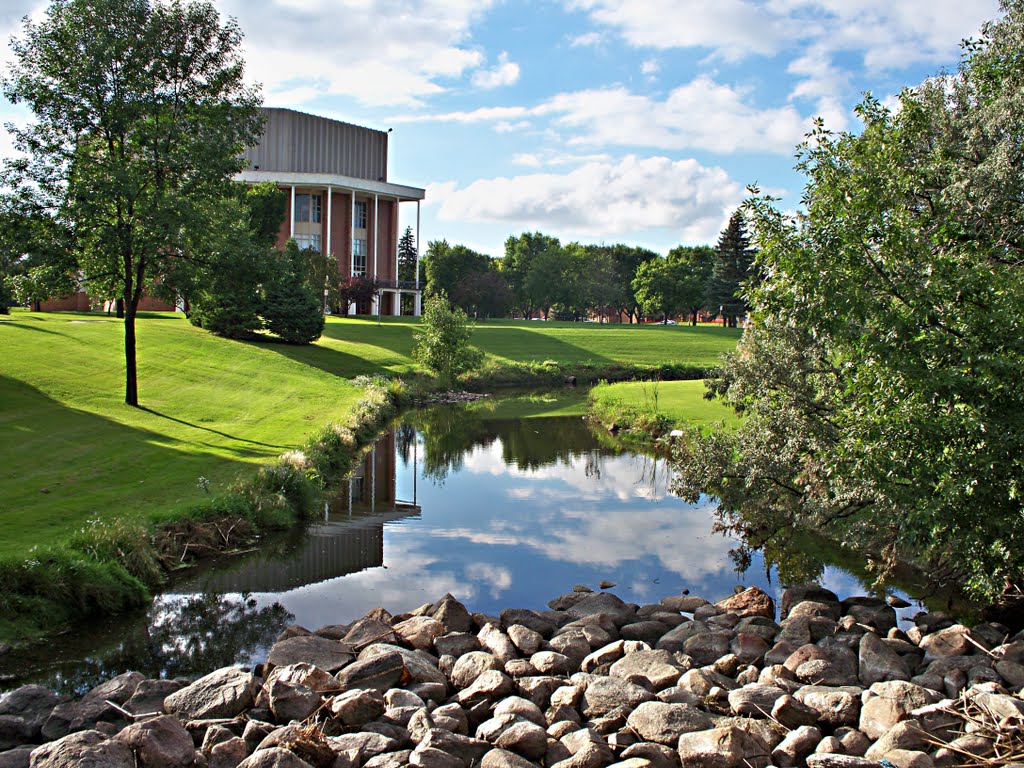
[0,310,738,556]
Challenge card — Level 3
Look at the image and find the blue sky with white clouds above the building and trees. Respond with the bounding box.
[0,0,999,257]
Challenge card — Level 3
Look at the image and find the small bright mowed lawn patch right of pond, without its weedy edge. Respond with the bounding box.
[593,381,739,428]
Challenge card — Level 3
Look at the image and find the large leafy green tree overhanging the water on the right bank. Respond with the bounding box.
[677,0,1024,597]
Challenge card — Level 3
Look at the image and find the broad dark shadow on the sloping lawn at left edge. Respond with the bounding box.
[0,376,276,554]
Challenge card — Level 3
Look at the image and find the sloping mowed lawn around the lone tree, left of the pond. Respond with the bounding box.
[0,311,360,556]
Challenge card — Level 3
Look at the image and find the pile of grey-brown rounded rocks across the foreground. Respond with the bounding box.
[0,585,1024,768]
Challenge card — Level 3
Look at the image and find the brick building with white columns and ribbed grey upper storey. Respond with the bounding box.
[236,108,425,314]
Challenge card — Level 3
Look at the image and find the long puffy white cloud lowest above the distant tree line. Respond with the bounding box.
[428,156,743,242]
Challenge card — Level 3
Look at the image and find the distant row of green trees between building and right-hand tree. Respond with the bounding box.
[415,211,756,328]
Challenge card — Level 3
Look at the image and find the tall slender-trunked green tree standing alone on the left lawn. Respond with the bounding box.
[3,0,261,406]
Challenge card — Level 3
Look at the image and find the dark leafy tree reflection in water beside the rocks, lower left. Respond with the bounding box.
[47,593,295,694]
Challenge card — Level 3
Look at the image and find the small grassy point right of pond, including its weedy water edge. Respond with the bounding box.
[589,381,739,442]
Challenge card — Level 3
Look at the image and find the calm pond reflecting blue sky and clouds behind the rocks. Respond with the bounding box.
[0,397,933,690]
